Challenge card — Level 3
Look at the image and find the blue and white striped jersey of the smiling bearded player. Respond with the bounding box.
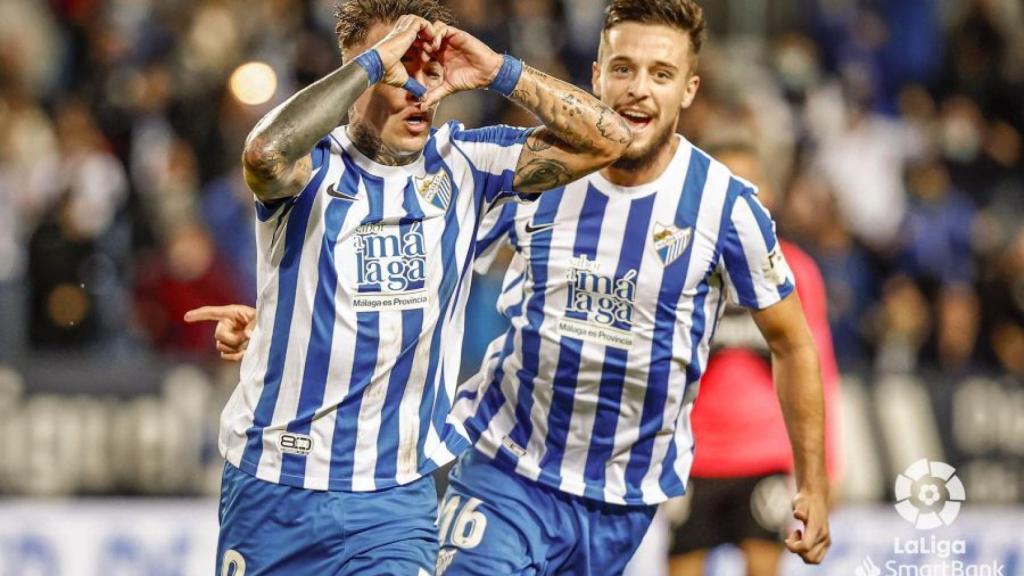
[450,137,795,504]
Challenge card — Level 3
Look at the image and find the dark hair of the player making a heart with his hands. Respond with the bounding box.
[334,0,455,49]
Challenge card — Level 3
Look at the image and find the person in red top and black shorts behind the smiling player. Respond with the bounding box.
[668,142,839,576]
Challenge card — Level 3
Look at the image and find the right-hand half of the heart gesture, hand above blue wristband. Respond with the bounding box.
[422,22,503,108]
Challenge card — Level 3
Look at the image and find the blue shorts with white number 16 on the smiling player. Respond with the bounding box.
[437,450,657,576]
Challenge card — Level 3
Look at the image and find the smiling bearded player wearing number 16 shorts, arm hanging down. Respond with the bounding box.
[437,0,829,576]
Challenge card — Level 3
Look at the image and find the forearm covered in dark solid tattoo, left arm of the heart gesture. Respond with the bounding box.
[242,63,369,197]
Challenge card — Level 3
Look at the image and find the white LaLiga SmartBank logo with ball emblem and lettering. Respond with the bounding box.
[854,459,1006,576]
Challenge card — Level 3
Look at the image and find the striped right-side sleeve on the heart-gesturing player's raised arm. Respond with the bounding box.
[452,124,536,211]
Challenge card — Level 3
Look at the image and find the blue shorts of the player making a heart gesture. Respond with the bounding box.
[216,463,437,576]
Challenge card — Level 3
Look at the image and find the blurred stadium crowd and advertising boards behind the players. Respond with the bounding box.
[0,0,1024,575]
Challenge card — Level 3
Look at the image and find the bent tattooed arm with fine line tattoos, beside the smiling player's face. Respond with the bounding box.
[510,66,632,192]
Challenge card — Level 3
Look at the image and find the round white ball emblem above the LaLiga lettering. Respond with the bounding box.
[896,459,967,530]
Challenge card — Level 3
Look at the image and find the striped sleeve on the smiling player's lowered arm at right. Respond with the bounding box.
[722,187,796,310]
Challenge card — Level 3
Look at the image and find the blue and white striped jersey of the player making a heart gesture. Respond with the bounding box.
[220,122,529,491]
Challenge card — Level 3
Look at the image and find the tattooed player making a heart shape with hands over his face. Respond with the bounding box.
[189,0,630,576]
